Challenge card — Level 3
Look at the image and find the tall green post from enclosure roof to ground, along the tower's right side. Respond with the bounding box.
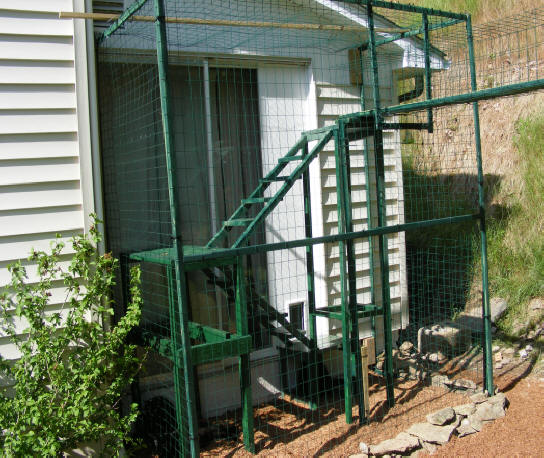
[367,0,395,407]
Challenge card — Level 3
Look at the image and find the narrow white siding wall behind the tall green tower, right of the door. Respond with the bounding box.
[316,78,408,346]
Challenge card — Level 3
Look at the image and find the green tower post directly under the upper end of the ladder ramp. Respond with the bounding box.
[337,121,365,423]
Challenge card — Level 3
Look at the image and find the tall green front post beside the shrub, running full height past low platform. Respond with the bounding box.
[155,0,199,458]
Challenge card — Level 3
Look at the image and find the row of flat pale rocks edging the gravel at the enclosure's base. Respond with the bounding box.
[350,393,508,458]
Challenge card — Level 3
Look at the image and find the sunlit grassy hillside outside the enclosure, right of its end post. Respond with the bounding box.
[394,0,544,335]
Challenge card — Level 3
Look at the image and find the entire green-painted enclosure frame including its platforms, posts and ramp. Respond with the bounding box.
[100,0,544,450]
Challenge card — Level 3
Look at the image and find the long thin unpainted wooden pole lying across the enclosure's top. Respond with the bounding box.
[59,11,410,33]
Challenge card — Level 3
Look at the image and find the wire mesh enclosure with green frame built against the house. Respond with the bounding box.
[93,0,543,456]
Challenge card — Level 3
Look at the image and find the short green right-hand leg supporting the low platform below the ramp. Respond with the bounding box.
[236,257,255,453]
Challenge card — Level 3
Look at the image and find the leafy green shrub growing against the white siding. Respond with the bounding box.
[0,217,142,456]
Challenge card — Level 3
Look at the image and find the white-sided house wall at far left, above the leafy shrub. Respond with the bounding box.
[0,0,94,358]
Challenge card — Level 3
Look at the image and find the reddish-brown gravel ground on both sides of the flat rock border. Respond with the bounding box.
[201,360,544,457]
